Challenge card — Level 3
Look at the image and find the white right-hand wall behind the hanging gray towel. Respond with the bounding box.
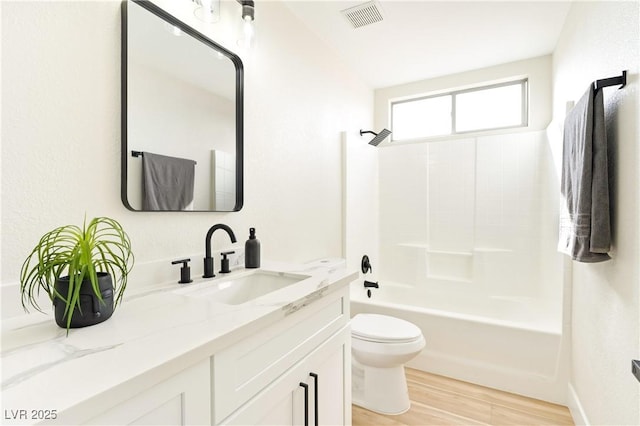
[553,2,640,425]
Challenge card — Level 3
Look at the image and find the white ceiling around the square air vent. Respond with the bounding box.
[282,0,570,88]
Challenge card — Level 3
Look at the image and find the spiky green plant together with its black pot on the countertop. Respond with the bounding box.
[20,217,134,333]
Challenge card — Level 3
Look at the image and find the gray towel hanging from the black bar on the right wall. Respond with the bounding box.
[558,85,611,262]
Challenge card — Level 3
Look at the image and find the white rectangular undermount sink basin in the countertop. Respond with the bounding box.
[176,270,309,305]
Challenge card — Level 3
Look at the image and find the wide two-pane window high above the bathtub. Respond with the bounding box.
[391,80,528,141]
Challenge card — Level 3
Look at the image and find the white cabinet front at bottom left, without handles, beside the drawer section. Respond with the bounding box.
[87,360,211,425]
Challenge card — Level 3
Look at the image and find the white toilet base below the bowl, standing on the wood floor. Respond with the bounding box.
[351,359,411,415]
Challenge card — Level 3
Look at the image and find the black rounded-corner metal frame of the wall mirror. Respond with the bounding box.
[120,0,244,213]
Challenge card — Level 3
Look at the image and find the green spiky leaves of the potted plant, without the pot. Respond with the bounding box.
[20,217,134,333]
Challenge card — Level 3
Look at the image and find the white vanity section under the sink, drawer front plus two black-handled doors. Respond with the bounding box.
[211,289,351,425]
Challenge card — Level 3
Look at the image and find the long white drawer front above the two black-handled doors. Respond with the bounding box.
[211,290,349,424]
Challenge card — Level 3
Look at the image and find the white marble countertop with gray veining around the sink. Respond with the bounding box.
[2,259,357,421]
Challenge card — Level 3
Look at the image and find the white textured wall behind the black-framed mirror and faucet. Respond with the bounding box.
[1,1,373,316]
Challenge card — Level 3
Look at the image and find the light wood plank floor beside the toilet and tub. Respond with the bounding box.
[352,368,573,426]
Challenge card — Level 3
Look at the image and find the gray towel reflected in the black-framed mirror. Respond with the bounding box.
[142,152,196,210]
